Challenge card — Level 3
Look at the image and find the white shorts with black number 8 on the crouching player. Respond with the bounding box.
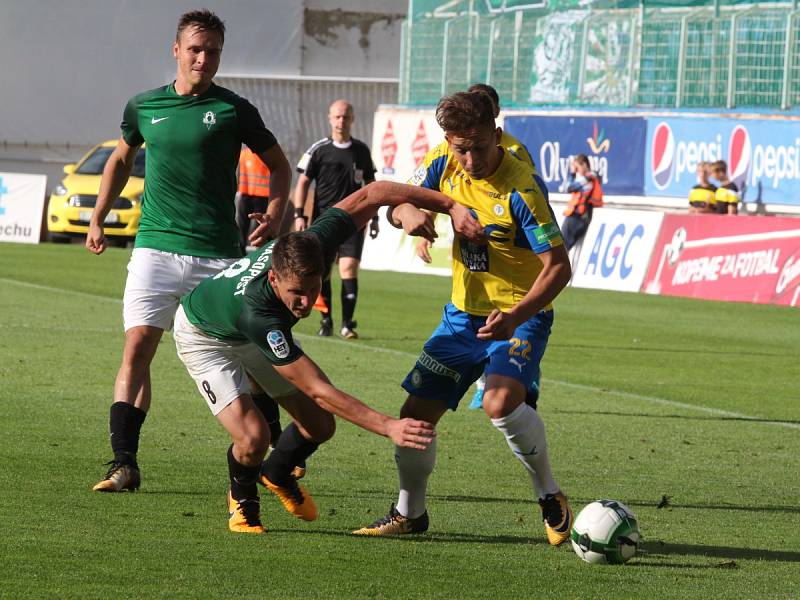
[174,306,299,415]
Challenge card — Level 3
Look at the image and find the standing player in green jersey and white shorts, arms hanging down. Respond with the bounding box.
[86,10,291,492]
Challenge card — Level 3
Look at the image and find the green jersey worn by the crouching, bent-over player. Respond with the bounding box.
[181,208,356,365]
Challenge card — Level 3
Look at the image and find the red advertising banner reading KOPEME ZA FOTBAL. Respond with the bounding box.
[642,215,800,306]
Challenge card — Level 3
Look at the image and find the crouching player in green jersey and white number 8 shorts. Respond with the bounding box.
[175,182,483,533]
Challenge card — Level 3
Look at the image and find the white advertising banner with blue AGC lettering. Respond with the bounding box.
[572,208,664,292]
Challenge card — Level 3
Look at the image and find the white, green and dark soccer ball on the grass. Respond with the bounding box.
[570,500,640,565]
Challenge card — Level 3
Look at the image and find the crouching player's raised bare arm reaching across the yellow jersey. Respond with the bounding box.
[336,181,485,243]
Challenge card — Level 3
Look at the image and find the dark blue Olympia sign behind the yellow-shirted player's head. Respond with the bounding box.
[503,115,646,196]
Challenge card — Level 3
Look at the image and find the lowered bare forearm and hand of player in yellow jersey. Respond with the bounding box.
[478,245,572,340]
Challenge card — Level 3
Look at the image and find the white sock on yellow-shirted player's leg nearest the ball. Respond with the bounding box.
[492,402,559,498]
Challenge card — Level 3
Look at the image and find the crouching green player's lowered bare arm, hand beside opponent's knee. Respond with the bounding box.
[275,356,436,450]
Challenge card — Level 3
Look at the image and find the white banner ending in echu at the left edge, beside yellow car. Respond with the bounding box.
[0,173,47,244]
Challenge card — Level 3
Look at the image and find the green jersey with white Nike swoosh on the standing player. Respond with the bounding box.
[122,83,277,258]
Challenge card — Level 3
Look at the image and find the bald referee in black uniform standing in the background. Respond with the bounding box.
[294,100,378,339]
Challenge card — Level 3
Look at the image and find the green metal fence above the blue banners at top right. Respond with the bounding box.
[399,0,800,109]
